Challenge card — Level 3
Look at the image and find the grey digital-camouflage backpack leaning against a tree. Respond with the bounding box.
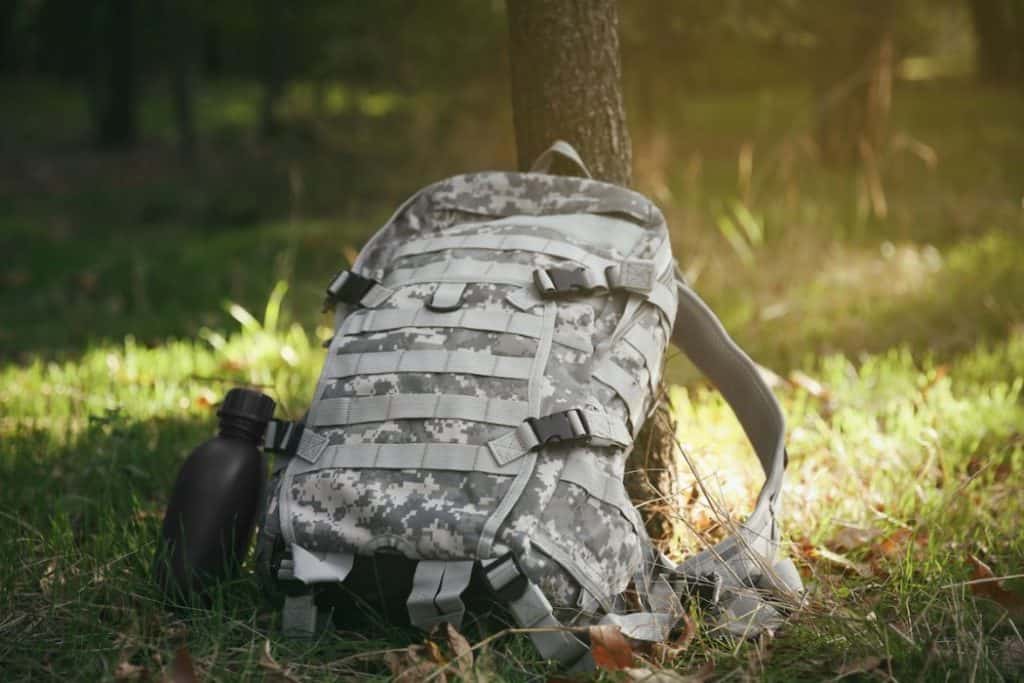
[257,142,800,669]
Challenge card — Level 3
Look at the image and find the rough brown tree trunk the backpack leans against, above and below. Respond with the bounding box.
[508,0,680,550]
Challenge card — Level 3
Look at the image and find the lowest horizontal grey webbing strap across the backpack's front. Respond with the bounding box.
[289,443,519,475]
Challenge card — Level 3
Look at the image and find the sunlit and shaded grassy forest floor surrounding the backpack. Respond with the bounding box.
[0,78,1024,680]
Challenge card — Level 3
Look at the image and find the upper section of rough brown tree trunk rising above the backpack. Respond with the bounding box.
[508,0,632,185]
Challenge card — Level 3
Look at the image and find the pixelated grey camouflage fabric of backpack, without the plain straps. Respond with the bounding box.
[260,172,675,623]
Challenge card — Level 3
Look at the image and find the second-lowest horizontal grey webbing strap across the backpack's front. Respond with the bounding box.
[309,393,529,427]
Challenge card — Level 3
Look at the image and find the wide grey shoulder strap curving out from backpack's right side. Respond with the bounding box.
[672,282,785,580]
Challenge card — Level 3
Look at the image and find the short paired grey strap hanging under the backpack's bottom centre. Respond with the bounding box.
[406,560,475,631]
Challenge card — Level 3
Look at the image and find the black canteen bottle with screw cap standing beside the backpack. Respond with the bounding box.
[155,389,274,598]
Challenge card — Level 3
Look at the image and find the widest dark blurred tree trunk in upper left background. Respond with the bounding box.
[97,0,138,147]
